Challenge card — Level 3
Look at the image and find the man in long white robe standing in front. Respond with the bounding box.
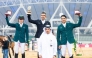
[38,25,57,58]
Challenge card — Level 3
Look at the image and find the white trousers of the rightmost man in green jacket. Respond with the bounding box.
[61,41,72,57]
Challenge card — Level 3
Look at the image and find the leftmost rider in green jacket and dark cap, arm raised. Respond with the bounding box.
[6,14,29,58]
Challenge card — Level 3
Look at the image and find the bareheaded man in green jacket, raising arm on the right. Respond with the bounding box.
[57,13,82,58]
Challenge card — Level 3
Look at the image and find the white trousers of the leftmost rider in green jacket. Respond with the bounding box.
[14,41,25,54]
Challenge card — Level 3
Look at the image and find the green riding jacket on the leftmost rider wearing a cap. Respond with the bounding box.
[6,17,29,43]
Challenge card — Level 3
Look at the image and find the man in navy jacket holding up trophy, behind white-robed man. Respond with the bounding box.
[27,12,50,58]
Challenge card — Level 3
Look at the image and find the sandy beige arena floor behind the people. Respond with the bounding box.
[0,47,92,58]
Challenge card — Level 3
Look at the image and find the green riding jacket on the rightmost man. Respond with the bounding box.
[57,17,82,45]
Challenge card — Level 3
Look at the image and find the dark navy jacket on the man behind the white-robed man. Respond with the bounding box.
[28,15,51,38]
